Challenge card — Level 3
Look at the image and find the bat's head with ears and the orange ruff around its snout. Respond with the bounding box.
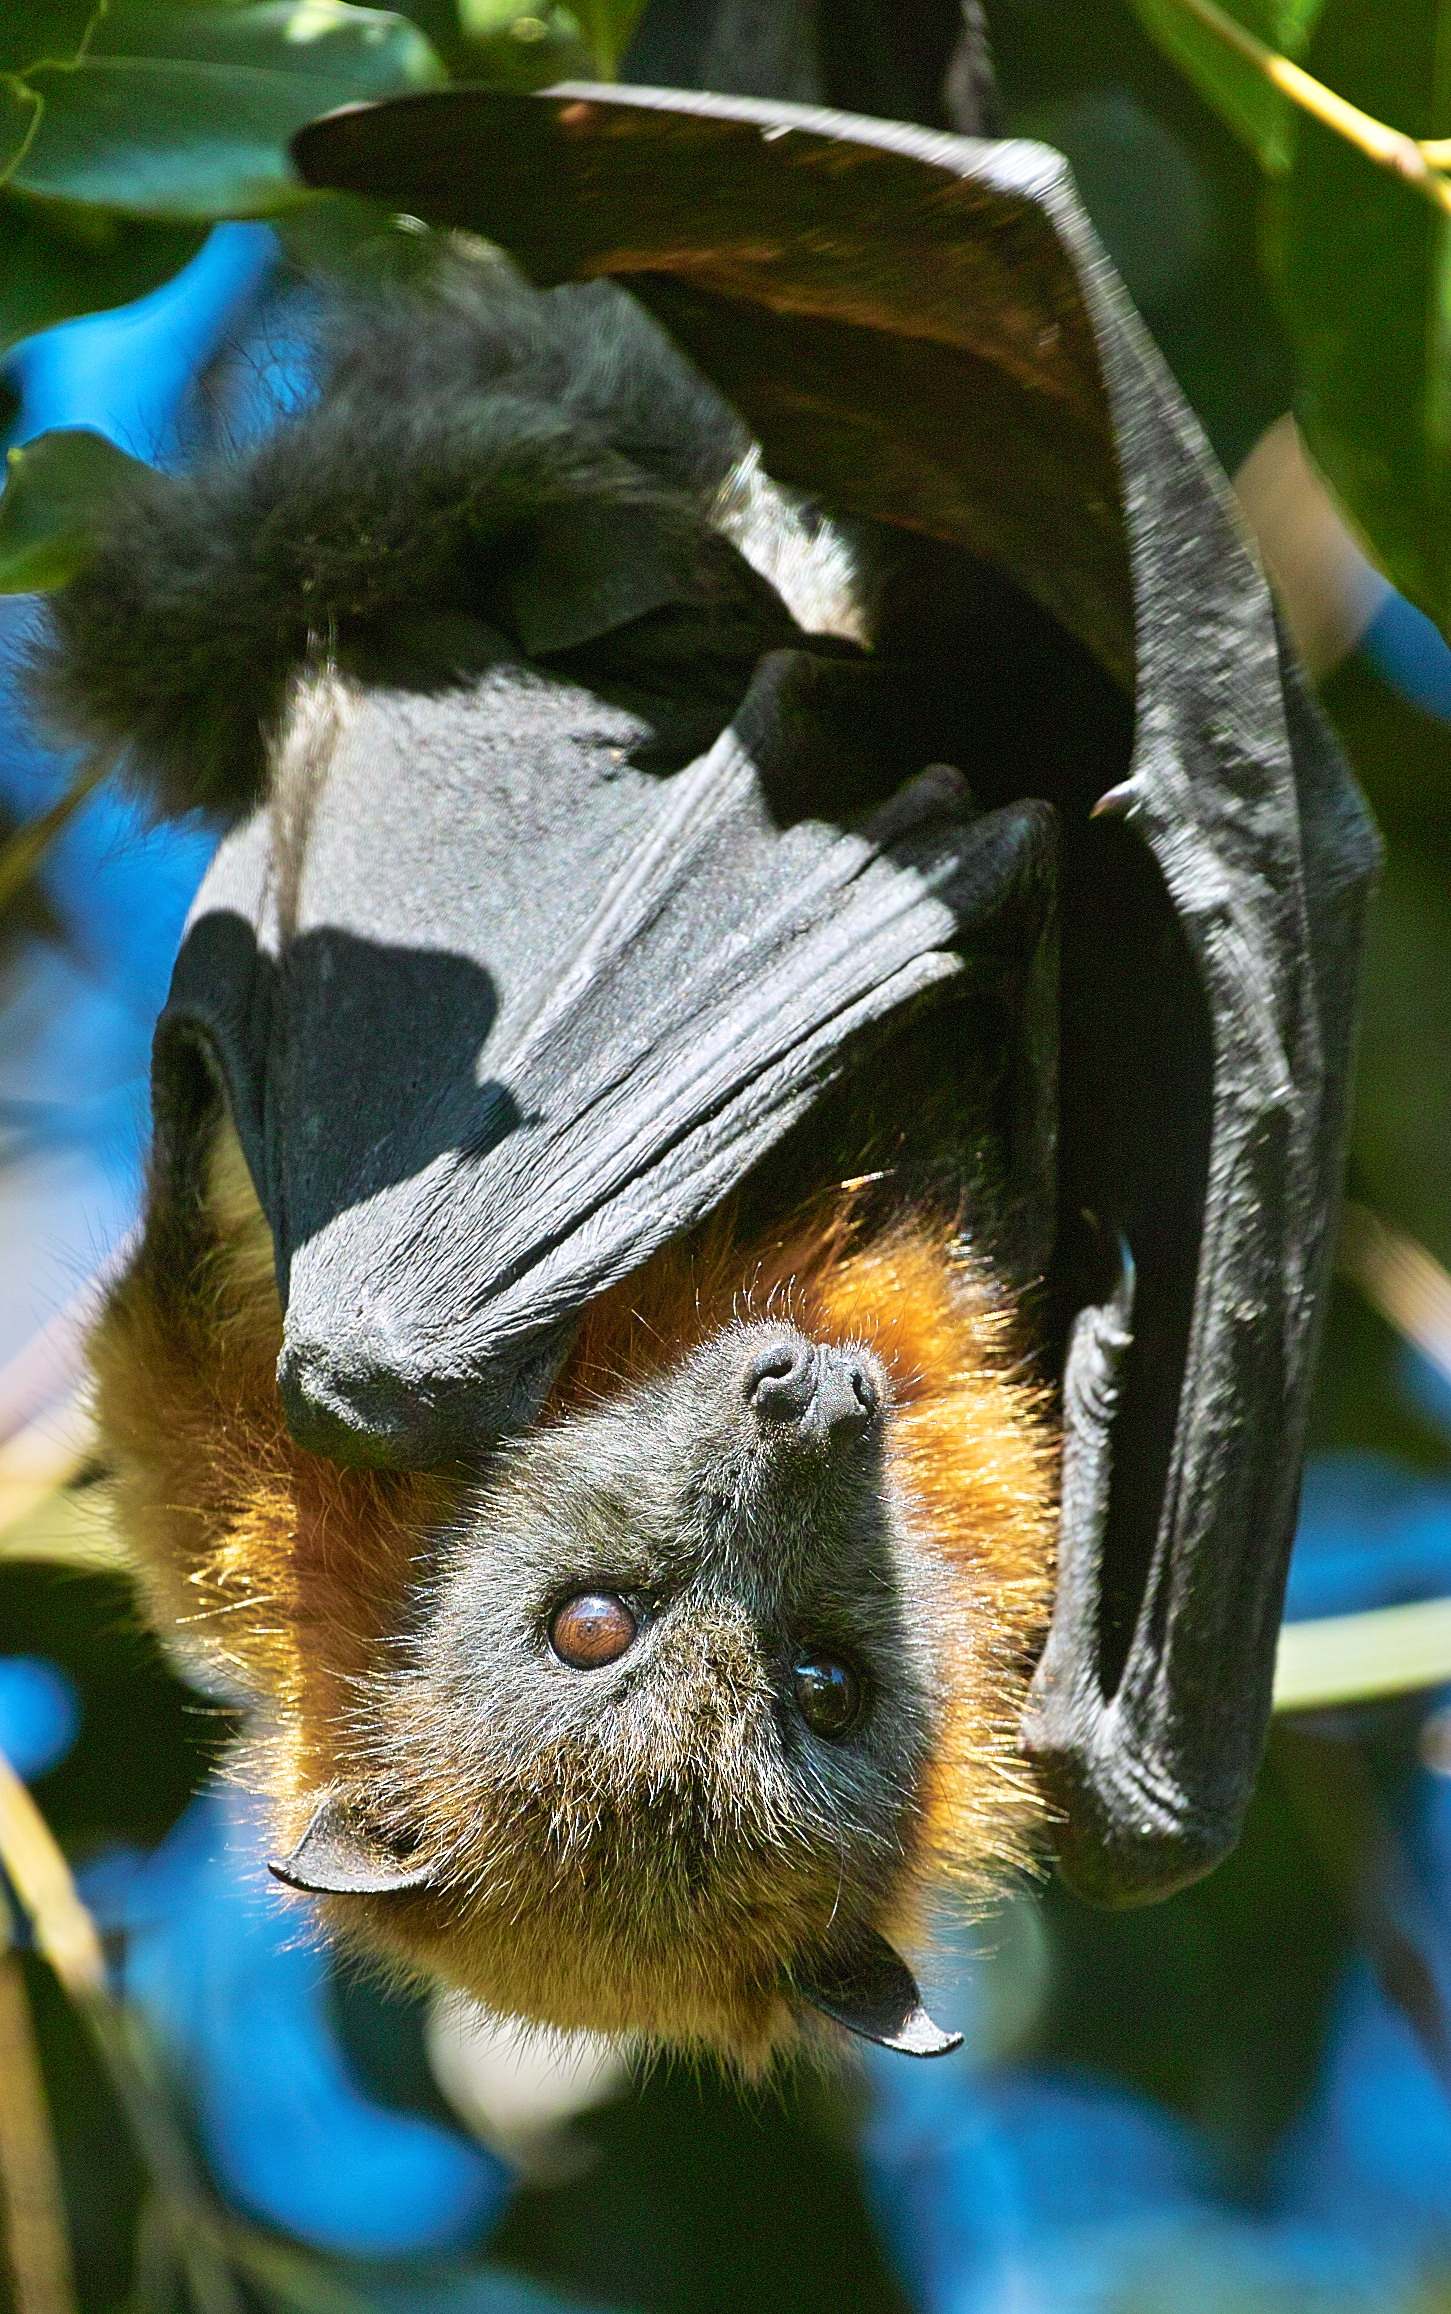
[261,1231,1051,2066]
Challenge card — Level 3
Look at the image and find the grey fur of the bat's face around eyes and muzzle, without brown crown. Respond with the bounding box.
[374,1321,933,1932]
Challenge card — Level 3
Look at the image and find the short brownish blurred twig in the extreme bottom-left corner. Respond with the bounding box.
[0,1897,76,2314]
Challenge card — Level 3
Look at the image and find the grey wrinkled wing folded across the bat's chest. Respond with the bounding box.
[155,650,1053,1465]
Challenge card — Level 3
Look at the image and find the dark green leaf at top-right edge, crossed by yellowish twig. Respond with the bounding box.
[1280,0,1451,625]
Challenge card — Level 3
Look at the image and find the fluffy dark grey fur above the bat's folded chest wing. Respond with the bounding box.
[30,248,851,812]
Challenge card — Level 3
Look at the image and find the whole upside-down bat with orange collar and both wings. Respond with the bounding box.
[37,90,1370,2064]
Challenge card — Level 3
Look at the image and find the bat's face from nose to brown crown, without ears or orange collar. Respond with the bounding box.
[342,1321,940,2053]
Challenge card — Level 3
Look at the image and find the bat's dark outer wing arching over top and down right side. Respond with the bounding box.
[296,88,1375,1902]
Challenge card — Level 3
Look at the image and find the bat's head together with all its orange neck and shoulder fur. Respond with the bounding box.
[93,1115,1055,2069]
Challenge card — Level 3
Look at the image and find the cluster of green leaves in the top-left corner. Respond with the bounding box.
[0,0,641,354]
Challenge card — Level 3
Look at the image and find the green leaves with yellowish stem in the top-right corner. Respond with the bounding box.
[1134,0,1451,627]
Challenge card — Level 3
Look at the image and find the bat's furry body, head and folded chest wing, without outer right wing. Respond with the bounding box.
[42,248,1055,2066]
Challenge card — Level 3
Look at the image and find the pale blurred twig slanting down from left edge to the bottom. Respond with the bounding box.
[0,1754,243,2314]
